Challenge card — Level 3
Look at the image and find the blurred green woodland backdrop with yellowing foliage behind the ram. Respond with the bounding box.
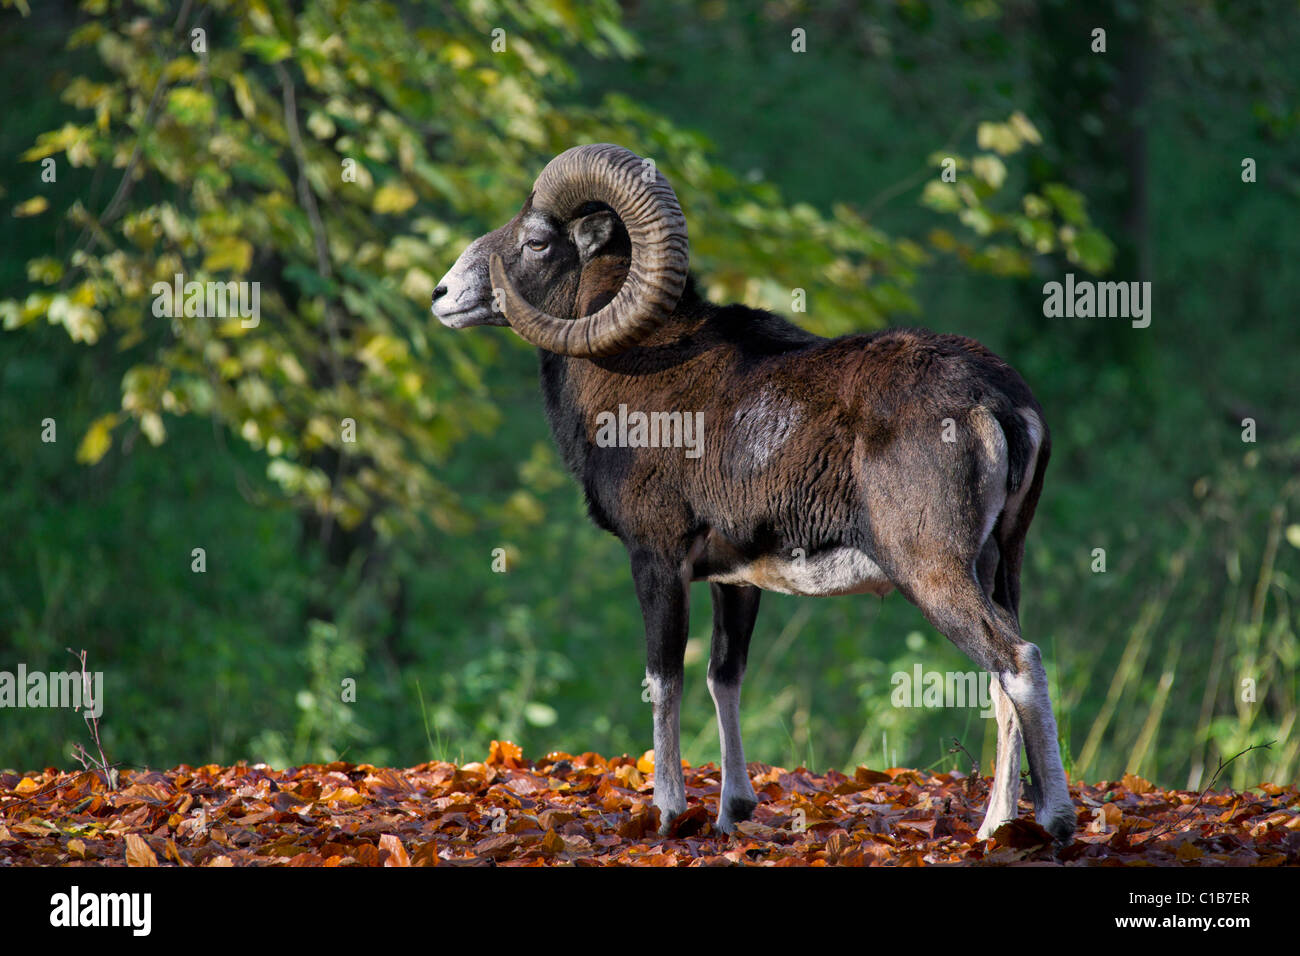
[0,0,1300,787]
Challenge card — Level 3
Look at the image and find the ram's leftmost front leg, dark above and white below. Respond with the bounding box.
[632,551,689,834]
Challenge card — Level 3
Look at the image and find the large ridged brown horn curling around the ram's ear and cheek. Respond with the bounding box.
[489,143,690,358]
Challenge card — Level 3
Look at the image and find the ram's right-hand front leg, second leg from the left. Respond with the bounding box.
[709,584,763,834]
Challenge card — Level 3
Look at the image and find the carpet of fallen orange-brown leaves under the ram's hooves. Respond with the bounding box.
[0,741,1300,866]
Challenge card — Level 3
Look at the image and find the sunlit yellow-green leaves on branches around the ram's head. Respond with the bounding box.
[0,1,1083,535]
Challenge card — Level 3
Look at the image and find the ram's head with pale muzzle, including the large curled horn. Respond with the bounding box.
[433,143,689,358]
